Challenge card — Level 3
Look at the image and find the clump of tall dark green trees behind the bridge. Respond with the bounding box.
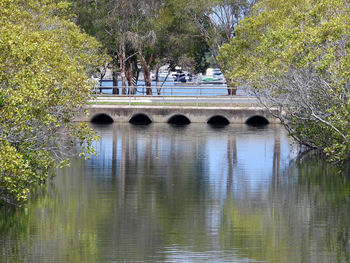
[71,0,212,95]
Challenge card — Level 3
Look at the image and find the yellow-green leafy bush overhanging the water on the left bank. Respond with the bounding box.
[0,0,105,203]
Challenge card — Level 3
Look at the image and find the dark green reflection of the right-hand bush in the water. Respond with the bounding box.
[290,154,350,262]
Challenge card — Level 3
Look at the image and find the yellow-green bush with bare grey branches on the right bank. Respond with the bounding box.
[220,0,350,163]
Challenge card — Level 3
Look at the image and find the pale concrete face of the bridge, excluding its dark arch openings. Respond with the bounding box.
[76,105,280,124]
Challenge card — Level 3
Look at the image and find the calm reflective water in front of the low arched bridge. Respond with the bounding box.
[0,124,350,263]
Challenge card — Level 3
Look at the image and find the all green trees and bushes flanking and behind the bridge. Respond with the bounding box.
[0,0,350,205]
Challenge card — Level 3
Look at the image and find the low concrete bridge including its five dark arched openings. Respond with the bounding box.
[75,105,280,124]
